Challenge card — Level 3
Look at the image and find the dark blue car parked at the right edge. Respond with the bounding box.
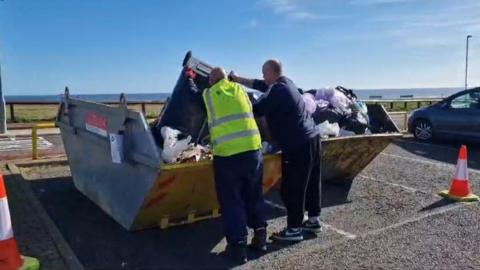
[408,87,480,142]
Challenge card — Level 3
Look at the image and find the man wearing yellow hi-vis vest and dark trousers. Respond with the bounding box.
[186,68,267,263]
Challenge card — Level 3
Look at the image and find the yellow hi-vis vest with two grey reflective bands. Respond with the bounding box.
[203,79,262,157]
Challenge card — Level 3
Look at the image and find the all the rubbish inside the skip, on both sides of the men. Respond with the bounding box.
[160,86,370,164]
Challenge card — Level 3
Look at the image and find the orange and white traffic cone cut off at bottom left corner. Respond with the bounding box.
[0,171,40,270]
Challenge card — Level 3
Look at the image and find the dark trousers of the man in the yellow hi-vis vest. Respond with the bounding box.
[213,150,267,244]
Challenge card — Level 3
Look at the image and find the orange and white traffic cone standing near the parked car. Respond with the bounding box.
[439,145,479,202]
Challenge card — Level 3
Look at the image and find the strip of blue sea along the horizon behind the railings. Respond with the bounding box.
[0,87,472,102]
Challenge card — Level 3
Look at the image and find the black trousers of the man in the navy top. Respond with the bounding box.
[281,136,322,228]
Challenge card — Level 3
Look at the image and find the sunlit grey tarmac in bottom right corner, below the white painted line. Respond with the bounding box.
[246,205,480,269]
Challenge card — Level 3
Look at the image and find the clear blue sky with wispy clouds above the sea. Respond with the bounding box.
[0,0,480,95]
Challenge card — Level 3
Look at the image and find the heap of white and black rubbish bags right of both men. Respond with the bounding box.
[303,86,370,138]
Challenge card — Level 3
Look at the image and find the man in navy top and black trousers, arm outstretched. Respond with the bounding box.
[230,60,321,241]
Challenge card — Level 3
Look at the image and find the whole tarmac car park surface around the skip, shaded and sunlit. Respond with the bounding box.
[3,139,480,269]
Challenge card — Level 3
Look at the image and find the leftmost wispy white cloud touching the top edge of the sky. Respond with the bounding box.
[257,0,322,21]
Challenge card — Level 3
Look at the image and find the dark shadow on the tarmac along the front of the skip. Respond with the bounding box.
[30,177,350,269]
